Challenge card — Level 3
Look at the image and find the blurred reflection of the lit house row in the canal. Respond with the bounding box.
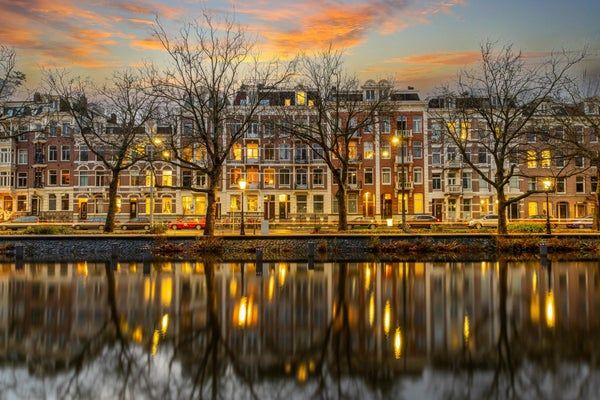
[0,262,600,380]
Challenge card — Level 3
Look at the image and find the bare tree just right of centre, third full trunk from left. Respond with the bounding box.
[283,47,390,231]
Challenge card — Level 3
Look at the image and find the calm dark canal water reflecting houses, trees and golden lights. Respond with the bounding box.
[0,261,600,400]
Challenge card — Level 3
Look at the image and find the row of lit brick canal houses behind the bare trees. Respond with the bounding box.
[0,81,599,221]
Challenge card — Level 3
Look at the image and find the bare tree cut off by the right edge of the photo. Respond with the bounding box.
[551,75,600,231]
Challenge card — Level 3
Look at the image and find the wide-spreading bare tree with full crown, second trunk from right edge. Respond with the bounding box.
[430,41,584,234]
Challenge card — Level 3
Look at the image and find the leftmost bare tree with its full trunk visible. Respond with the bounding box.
[45,70,157,232]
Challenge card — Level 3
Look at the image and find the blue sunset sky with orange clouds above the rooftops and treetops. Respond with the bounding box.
[0,0,600,94]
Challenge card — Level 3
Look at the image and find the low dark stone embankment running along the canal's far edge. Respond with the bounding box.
[0,234,600,262]
